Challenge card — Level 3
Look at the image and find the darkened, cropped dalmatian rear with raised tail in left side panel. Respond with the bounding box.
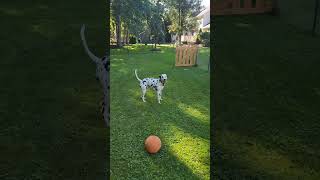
[80,25,110,126]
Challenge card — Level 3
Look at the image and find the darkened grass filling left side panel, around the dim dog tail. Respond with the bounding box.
[0,0,109,180]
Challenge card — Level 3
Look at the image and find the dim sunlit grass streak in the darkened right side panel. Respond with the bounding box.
[217,131,320,179]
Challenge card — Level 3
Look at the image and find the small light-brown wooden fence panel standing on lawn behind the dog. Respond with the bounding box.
[176,45,198,66]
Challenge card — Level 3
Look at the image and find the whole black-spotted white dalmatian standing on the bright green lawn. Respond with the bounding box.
[134,69,168,104]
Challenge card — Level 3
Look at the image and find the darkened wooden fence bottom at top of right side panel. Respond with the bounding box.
[211,0,273,15]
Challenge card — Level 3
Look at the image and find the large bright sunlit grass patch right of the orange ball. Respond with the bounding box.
[166,125,210,179]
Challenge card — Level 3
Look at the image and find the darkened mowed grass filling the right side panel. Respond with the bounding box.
[212,15,320,180]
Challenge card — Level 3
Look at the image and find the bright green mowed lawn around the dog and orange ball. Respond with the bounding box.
[110,45,210,179]
